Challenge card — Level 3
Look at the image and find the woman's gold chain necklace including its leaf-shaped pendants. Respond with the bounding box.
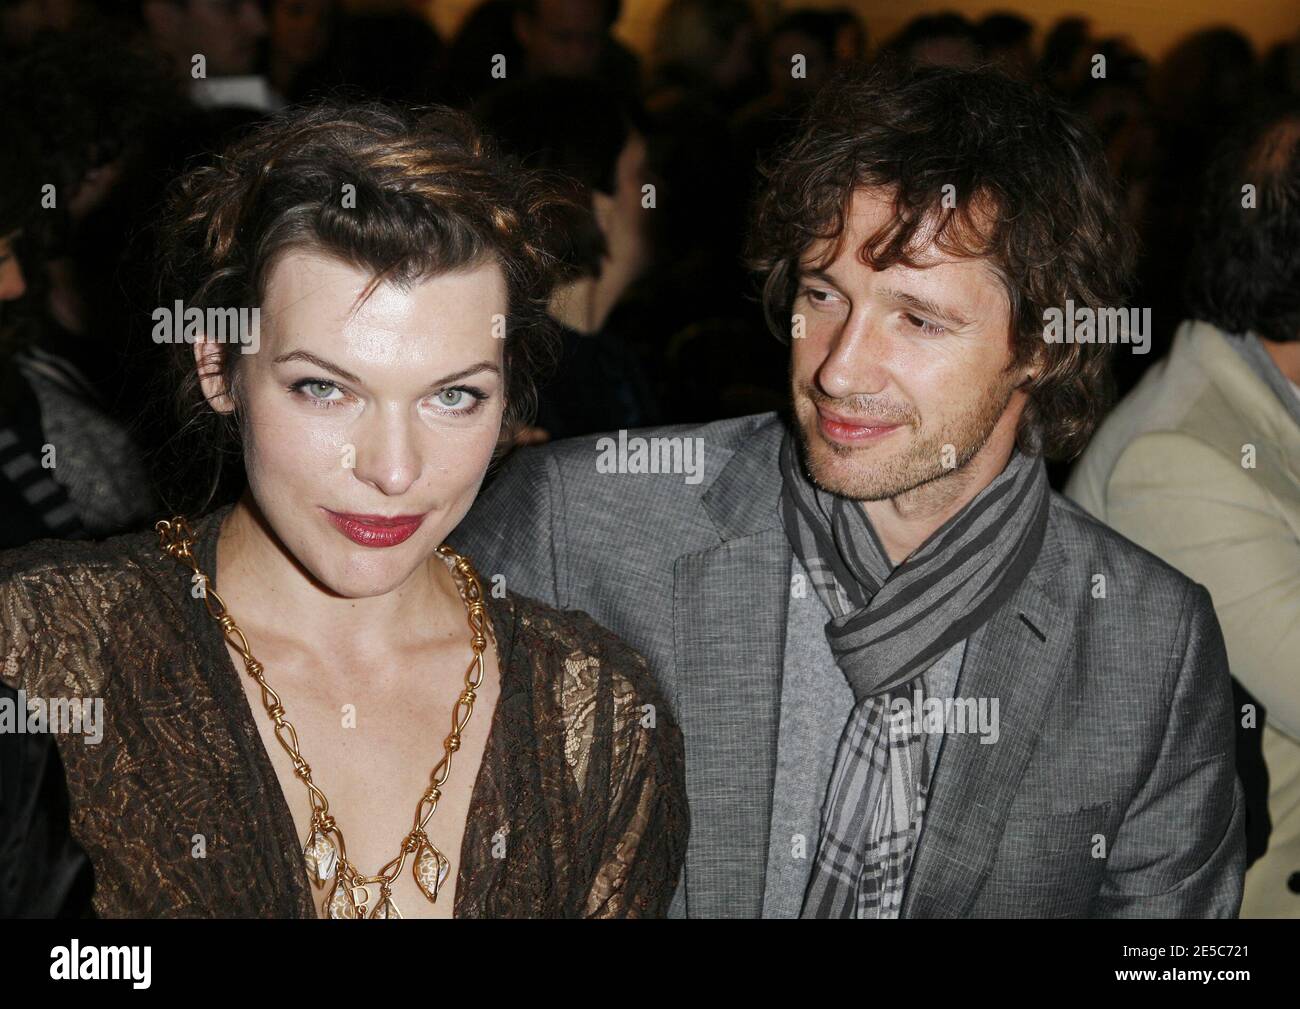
[153,515,491,919]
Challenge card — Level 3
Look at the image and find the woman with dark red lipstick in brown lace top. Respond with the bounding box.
[0,105,688,918]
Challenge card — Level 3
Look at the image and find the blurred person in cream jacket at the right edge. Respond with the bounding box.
[1066,100,1300,918]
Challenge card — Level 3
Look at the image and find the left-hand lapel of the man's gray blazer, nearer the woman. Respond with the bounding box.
[673,421,790,918]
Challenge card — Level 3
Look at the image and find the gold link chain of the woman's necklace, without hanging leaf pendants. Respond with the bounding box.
[153,515,491,918]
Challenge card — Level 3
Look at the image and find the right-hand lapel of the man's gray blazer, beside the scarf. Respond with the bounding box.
[900,525,1070,918]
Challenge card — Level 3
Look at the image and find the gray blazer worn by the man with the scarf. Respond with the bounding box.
[450,413,1245,918]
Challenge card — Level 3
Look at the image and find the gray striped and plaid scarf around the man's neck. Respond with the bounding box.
[780,432,1050,918]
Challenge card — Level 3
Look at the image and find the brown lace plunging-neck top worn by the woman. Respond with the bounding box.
[0,506,688,918]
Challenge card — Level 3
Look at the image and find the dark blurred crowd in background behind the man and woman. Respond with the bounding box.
[0,0,1300,545]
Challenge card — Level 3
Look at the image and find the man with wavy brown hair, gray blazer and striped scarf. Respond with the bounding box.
[456,65,1244,918]
